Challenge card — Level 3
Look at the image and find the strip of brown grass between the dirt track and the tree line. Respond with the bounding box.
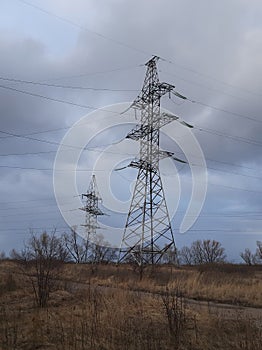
[59,264,262,308]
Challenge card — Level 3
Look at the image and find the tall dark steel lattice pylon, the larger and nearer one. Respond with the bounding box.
[119,56,184,266]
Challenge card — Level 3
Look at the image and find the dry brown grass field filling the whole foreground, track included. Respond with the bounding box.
[0,260,262,350]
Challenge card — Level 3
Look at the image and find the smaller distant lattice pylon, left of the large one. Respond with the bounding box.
[80,175,104,242]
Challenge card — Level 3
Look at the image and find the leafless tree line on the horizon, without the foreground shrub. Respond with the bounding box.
[0,228,262,265]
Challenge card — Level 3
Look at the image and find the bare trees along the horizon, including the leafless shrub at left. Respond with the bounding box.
[0,229,262,307]
